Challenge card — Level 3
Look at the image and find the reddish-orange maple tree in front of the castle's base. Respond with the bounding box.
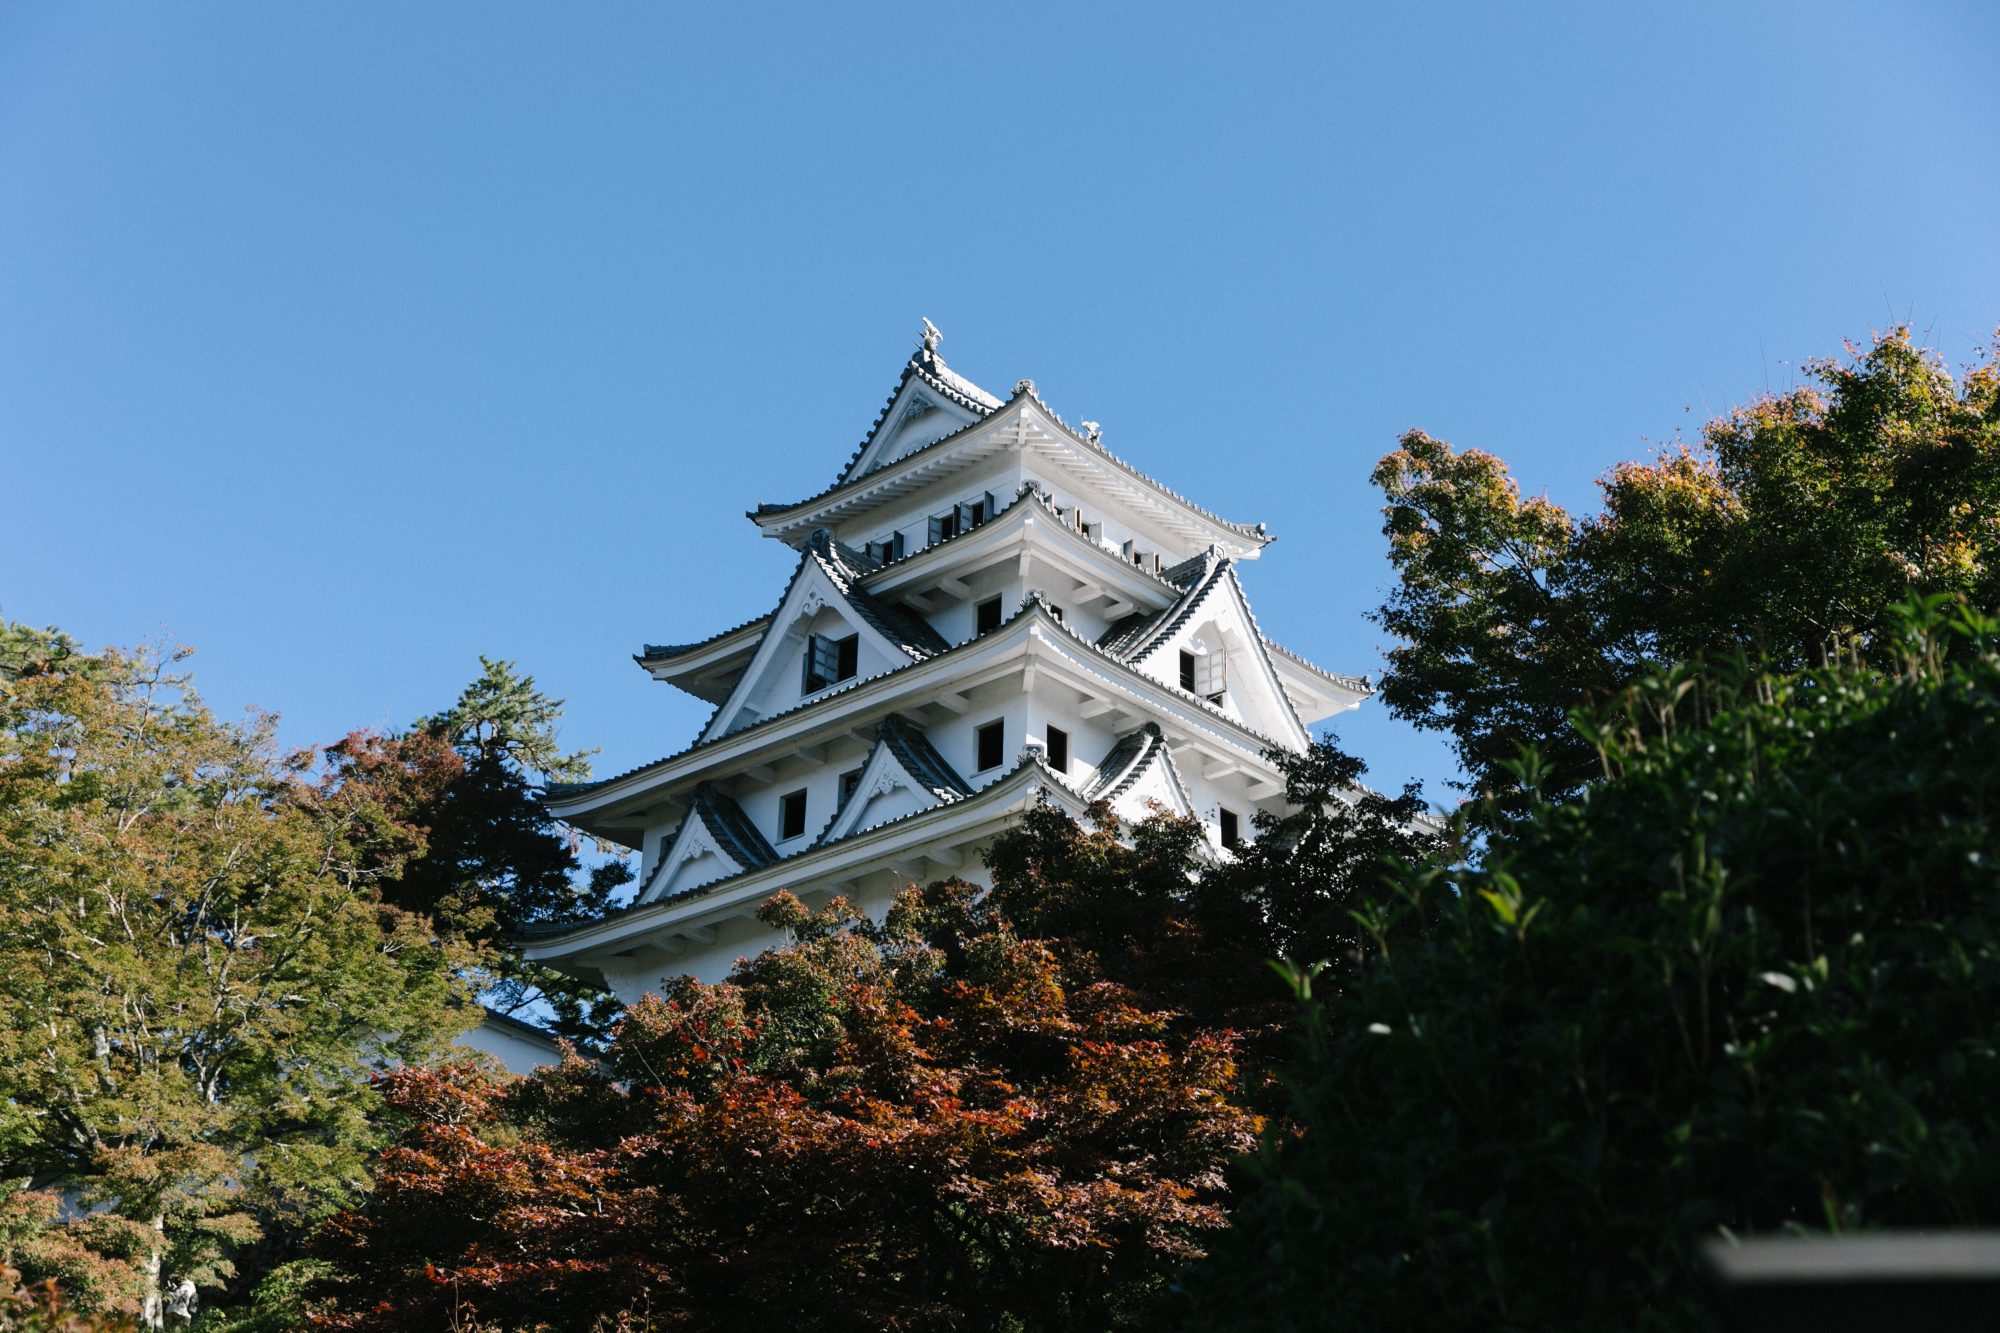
[312,883,1256,1331]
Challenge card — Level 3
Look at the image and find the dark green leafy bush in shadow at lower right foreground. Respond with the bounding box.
[1188,598,2000,1331]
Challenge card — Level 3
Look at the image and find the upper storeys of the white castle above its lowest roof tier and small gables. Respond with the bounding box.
[550,320,1368,855]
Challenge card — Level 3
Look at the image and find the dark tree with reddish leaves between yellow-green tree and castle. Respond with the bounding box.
[326,656,632,1045]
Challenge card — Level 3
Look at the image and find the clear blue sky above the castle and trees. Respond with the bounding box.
[0,0,2000,799]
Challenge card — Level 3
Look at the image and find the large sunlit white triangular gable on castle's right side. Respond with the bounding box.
[1128,550,1312,751]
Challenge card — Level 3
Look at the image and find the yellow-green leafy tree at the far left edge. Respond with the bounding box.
[0,634,472,1327]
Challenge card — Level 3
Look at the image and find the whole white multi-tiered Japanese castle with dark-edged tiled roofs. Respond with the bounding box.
[526,320,1368,1003]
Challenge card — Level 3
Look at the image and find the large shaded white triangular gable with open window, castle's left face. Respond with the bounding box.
[702,528,950,741]
